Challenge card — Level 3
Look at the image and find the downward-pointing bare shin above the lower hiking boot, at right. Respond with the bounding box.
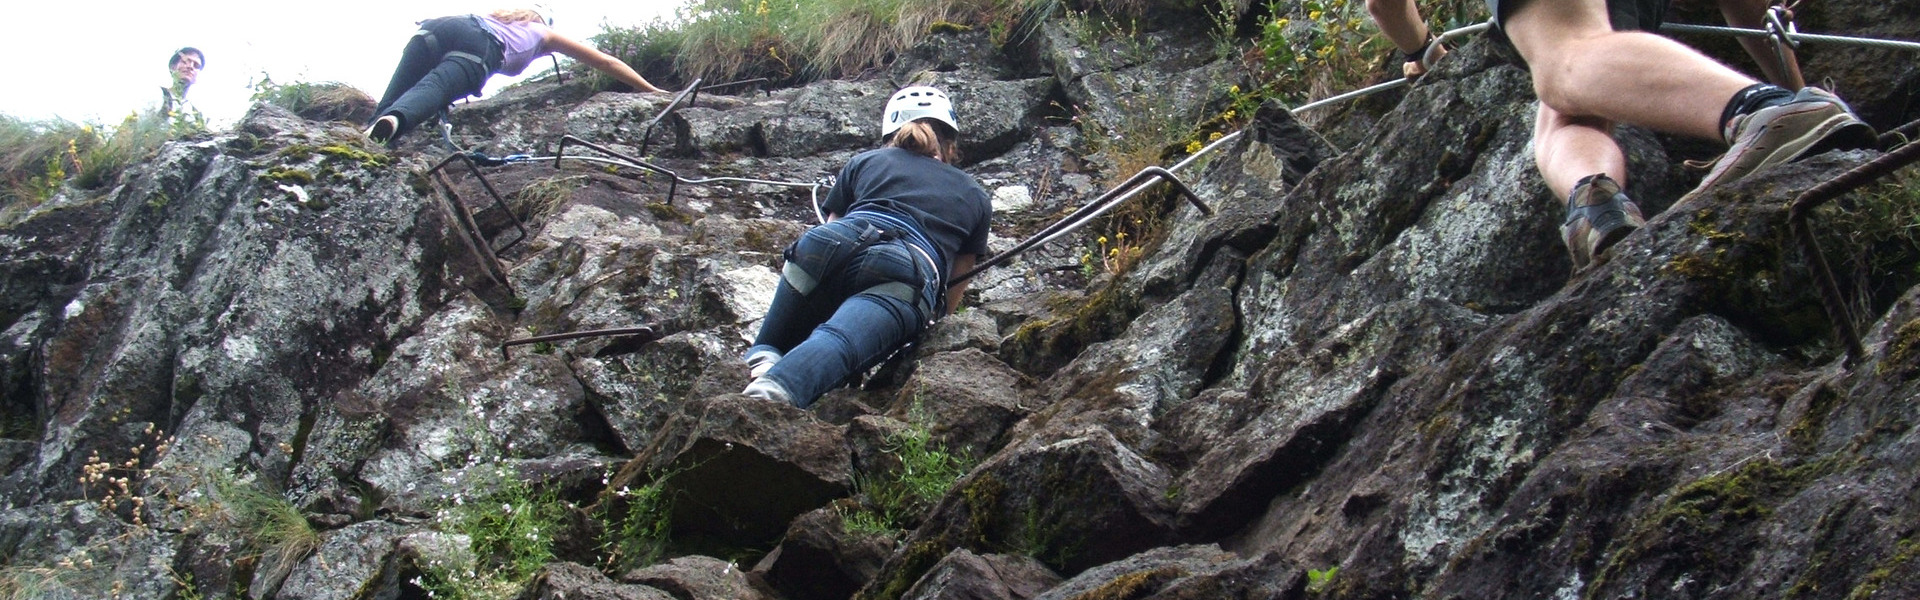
[1534,104,1626,202]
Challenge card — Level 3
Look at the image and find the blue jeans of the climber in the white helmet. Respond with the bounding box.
[747,212,939,408]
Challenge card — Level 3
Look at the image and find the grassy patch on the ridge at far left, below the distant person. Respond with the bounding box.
[0,113,177,223]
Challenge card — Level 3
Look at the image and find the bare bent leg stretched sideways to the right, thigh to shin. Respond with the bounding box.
[1505,0,1755,140]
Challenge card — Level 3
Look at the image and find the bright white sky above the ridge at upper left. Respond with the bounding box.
[0,0,685,127]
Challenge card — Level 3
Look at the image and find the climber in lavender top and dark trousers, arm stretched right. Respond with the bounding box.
[367,10,662,144]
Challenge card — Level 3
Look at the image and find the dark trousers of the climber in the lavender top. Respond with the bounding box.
[372,15,505,138]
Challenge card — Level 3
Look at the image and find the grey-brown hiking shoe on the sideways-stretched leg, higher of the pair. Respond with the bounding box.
[1695,87,1880,190]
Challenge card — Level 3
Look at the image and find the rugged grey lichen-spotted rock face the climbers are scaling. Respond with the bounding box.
[0,2,1920,600]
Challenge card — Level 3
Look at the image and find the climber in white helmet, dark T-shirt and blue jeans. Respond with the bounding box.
[741,87,993,408]
